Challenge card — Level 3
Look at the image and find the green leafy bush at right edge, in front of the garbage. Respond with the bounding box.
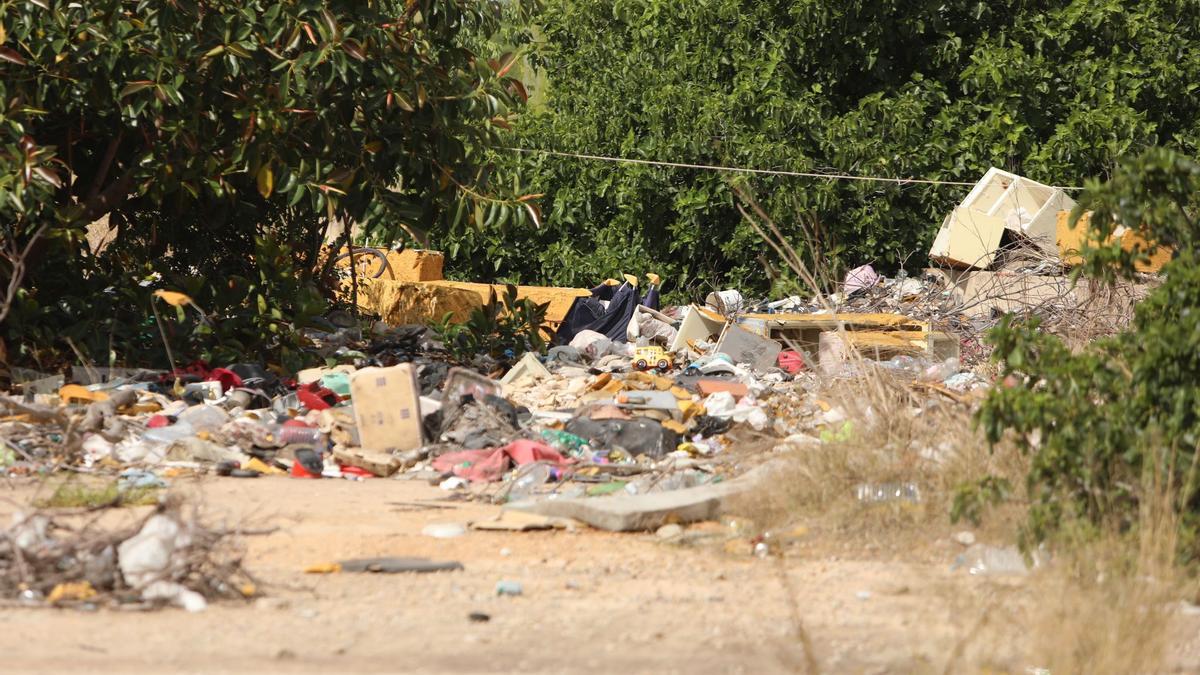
[979,149,1200,560]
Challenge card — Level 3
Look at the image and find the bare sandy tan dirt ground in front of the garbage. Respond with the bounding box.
[0,478,1200,673]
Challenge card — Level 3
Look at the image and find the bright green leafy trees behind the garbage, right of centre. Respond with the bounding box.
[446,0,1200,298]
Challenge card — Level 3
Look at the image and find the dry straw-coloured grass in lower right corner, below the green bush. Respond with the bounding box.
[965,444,1198,675]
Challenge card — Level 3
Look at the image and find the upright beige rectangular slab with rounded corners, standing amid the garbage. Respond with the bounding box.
[350,363,425,450]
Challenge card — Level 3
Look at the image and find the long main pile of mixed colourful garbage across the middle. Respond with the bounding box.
[0,267,978,502]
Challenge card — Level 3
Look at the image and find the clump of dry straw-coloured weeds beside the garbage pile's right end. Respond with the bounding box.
[739,369,1027,534]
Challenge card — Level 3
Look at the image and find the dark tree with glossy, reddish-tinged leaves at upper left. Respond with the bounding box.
[0,0,536,360]
